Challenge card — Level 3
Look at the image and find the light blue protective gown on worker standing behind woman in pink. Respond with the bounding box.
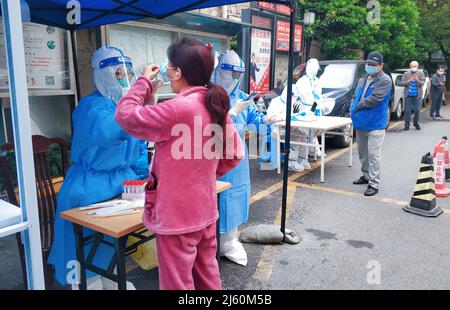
[219,90,265,234]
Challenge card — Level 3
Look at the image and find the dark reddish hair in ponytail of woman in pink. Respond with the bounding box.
[167,38,230,127]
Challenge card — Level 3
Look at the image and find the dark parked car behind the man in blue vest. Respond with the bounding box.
[260,60,398,148]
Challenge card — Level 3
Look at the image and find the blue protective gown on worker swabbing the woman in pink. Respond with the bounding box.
[48,91,148,285]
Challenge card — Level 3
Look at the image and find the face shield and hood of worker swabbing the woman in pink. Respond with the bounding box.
[93,47,136,103]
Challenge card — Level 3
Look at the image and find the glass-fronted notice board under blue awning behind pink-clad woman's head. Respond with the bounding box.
[102,12,250,100]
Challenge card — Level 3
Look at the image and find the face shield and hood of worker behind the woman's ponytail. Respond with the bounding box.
[214,51,245,96]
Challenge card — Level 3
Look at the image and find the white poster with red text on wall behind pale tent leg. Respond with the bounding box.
[0,23,70,90]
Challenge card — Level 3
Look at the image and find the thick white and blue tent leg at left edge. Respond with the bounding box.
[1,0,45,290]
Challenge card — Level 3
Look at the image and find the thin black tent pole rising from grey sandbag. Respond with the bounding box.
[281,0,297,241]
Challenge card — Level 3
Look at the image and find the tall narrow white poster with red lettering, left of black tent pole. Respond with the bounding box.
[250,29,272,94]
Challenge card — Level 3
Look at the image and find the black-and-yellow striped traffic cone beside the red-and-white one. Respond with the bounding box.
[403,153,442,217]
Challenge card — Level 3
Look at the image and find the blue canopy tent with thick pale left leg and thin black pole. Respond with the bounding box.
[0,0,297,289]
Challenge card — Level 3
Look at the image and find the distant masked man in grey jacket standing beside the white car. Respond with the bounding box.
[400,61,425,130]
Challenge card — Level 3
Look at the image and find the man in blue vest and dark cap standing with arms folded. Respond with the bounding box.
[350,52,392,196]
